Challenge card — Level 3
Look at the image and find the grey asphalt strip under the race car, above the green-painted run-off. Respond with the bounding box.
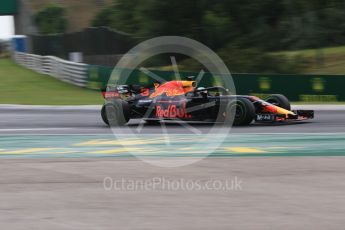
[0,107,345,135]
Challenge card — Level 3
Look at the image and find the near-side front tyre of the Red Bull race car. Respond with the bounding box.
[225,98,256,126]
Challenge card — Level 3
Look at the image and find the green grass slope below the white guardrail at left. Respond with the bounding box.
[0,59,103,105]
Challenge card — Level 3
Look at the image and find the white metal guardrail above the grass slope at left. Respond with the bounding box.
[13,52,88,87]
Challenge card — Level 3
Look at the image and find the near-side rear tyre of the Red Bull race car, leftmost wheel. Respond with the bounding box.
[101,100,130,126]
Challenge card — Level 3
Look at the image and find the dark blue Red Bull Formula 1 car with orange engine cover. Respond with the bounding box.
[101,80,314,126]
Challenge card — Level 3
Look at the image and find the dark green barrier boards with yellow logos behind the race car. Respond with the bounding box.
[87,65,345,102]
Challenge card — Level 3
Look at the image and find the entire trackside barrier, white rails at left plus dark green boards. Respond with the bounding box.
[13,52,345,102]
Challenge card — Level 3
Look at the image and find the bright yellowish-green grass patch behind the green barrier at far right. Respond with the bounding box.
[273,46,345,74]
